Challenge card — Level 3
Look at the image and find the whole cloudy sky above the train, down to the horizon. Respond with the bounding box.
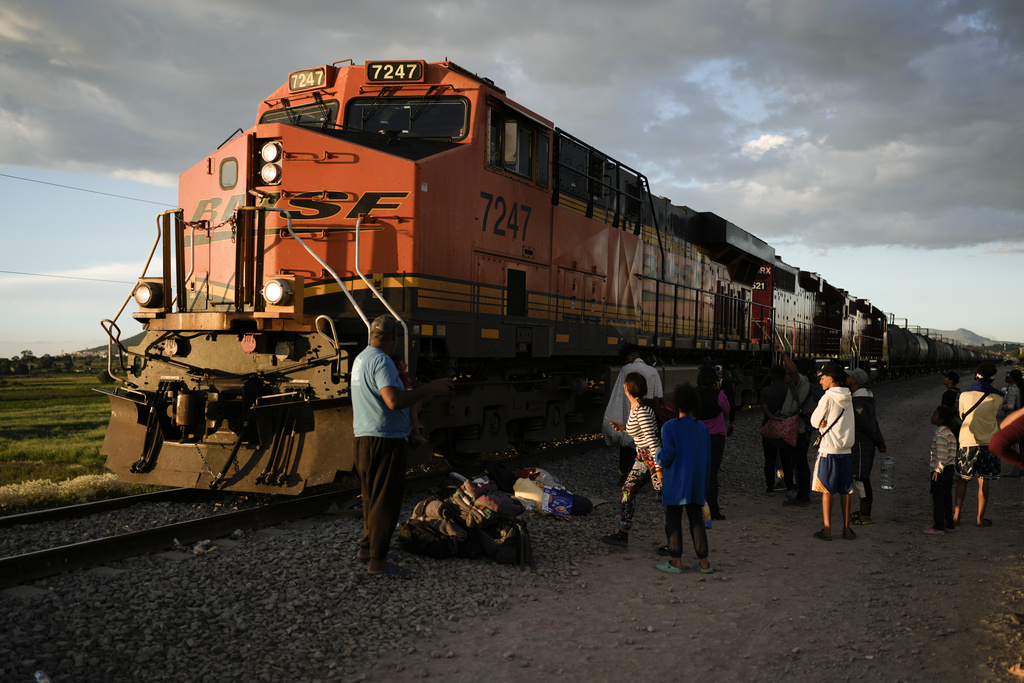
[0,0,1024,357]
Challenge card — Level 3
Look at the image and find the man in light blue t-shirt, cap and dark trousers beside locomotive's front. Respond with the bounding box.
[349,315,453,575]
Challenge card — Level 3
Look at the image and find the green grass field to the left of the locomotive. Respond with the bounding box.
[0,374,149,512]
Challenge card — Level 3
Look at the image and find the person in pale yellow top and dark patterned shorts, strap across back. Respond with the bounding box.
[953,362,1002,526]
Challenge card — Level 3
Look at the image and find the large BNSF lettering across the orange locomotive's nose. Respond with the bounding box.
[191,193,405,225]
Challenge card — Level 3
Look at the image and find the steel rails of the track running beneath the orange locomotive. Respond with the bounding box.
[0,438,597,589]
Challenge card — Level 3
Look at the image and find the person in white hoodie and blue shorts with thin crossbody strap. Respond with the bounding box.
[811,362,857,541]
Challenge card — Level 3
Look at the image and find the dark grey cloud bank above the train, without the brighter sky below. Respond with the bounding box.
[0,0,1024,249]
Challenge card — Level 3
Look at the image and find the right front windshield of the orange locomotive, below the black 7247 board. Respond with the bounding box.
[345,97,469,139]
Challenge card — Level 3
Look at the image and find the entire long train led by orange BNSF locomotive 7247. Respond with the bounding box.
[102,60,987,494]
